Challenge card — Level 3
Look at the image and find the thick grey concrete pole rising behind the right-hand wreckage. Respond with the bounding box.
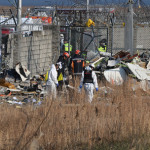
[125,0,134,55]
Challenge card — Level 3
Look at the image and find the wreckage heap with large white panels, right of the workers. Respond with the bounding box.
[90,51,150,91]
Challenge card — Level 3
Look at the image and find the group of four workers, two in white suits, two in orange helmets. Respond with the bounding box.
[46,49,98,102]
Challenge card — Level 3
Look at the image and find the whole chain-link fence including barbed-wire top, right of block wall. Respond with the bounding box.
[57,0,150,56]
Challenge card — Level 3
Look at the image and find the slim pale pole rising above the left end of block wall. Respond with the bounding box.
[17,0,22,31]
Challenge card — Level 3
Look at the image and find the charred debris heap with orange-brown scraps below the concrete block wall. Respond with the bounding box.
[0,63,46,107]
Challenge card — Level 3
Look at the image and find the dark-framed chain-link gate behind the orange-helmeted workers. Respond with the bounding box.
[61,27,108,53]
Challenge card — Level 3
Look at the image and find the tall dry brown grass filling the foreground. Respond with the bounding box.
[0,79,150,150]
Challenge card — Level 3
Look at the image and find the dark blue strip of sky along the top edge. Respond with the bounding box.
[0,0,150,6]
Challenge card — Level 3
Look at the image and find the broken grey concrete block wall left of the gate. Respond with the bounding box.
[7,26,60,76]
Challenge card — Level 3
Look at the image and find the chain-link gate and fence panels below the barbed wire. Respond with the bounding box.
[60,24,150,57]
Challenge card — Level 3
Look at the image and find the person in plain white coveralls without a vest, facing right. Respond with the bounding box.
[46,64,59,99]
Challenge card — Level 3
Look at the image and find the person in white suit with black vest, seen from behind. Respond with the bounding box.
[79,65,98,103]
